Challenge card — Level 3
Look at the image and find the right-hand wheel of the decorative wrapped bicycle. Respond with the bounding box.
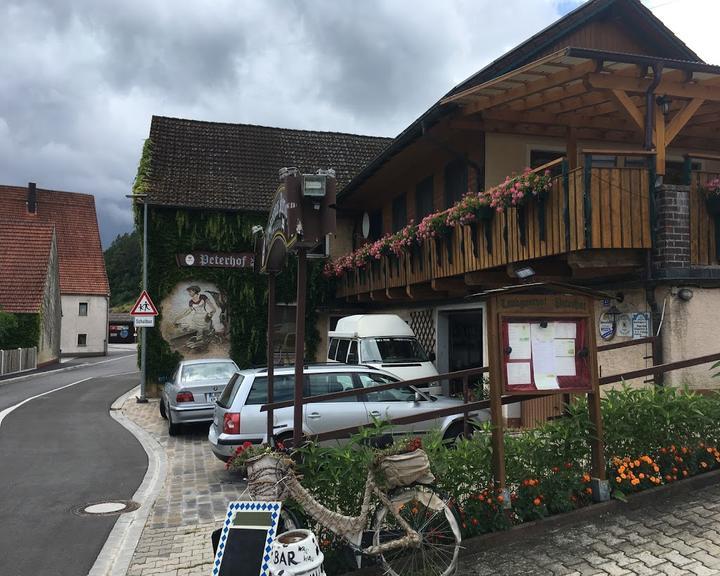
[373,485,462,576]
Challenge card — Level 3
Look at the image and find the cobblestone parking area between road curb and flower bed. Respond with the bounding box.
[122,399,245,576]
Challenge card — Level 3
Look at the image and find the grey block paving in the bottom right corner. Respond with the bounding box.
[459,485,720,576]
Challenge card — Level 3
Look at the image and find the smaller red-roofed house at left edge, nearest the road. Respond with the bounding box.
[0,220,62,365]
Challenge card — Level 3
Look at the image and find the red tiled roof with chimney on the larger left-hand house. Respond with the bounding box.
[0,186,110,295]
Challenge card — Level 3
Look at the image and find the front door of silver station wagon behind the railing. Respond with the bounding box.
[357,372,437,436]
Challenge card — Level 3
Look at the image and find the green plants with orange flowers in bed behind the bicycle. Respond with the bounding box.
[282,387,720,550]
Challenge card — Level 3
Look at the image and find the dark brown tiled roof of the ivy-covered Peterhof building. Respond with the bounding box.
[148,116,392,212]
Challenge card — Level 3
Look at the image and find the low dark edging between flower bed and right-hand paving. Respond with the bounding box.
[344,469,720,576]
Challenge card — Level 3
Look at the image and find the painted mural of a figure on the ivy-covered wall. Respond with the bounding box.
[160,281,230,358]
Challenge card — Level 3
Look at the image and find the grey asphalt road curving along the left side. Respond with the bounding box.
[0,350,147,576]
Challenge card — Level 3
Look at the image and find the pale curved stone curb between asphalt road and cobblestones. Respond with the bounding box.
[88,386,167,576]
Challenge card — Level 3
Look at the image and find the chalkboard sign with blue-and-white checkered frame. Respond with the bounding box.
[212,502,282,576]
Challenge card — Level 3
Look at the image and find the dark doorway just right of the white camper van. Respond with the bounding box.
[448,310,484,394]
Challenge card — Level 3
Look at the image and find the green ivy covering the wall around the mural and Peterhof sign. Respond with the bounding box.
[135,205,332,382]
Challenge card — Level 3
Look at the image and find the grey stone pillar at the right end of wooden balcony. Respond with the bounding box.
[653,184,690,270]
